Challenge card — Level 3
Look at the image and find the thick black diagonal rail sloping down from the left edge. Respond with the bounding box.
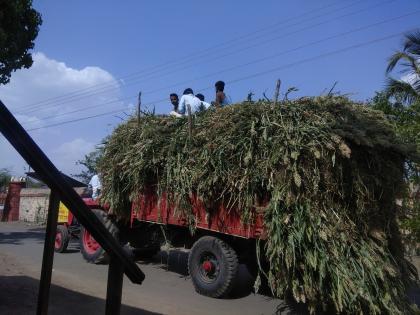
[0,101,145,284]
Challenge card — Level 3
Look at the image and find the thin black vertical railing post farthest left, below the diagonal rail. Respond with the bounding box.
[36,191,60,315]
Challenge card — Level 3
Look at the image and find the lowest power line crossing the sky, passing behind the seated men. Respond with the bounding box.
[28,30,412,131]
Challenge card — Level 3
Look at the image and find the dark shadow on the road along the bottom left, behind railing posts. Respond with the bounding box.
[0,276,159,315]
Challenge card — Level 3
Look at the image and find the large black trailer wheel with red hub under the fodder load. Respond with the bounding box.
[188,236,238,298]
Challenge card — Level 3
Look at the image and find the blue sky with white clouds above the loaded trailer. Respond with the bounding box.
[0,0,420,175]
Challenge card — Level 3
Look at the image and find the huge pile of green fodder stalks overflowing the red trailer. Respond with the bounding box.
[101,97,415,314]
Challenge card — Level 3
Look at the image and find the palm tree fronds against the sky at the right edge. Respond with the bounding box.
[386,30,420,104]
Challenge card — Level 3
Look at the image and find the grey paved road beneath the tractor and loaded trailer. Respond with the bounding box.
[0,223,297,315]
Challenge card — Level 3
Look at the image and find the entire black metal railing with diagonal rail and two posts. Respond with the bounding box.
[0,101,145,315]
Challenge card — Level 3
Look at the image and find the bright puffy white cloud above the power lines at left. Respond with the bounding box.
[0,53,120,122]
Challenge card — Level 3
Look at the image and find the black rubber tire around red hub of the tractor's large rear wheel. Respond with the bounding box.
[79,209,119,264]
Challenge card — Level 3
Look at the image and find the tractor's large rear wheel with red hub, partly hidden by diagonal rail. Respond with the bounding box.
[79,209,119,264]
